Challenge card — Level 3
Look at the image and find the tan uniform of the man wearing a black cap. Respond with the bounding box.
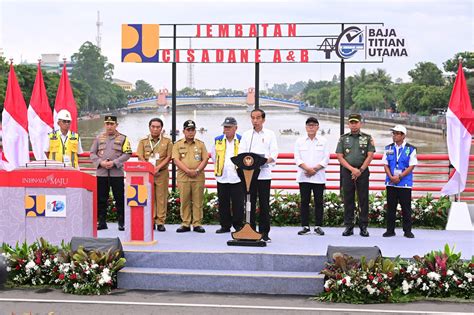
[172,138,208,228]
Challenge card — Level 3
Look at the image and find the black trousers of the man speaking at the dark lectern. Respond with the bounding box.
[250,179,271,235]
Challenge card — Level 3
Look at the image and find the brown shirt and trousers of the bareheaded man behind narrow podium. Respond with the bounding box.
[137,135,173,225]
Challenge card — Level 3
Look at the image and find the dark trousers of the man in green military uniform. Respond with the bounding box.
[341,168,370,227]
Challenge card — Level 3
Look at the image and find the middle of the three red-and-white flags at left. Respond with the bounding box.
[28,63,53,160]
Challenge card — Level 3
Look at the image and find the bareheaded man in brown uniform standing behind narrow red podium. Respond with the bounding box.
[137,118,173,232]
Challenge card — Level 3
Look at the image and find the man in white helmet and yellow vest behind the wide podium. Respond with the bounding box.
[48,109,83,168]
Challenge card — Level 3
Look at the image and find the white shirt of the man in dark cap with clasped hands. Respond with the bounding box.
[294,136,330,184]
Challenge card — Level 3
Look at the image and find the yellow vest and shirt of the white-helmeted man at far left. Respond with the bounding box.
[48,130,82,168]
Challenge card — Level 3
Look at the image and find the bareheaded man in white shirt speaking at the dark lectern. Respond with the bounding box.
[239,109,278,242]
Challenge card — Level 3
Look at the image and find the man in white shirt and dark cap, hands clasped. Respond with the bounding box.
[294,117,330,235]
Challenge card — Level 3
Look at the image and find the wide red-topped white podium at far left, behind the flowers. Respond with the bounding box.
[0,168,97,245]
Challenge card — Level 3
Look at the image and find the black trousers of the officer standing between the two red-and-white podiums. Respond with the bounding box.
[97,176,125,226]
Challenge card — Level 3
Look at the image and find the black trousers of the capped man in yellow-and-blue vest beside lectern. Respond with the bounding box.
[217,182,244,230]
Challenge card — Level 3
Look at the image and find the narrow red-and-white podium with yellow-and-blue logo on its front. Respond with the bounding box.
[122,162,156,245]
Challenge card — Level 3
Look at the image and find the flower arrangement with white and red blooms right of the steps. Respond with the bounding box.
[317,245,474,303]
